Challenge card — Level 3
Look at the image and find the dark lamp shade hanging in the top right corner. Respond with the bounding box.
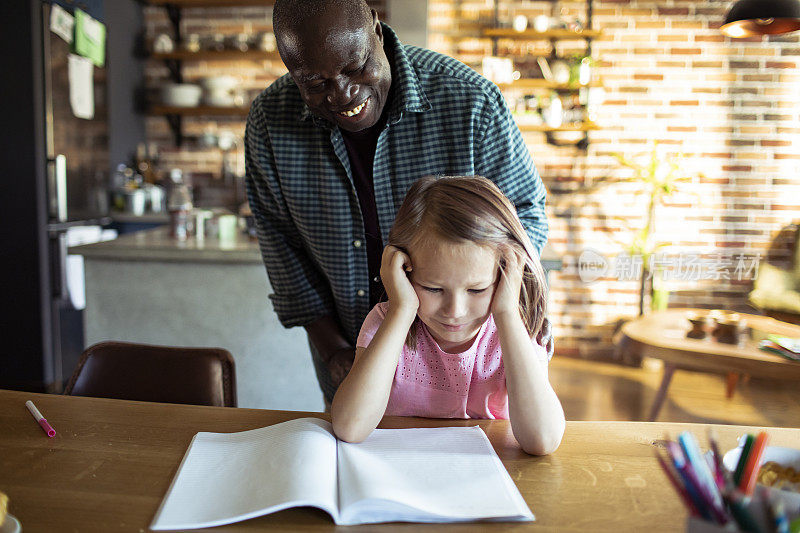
[720,0,800,37]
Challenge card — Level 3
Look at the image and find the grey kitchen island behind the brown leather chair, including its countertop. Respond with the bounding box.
[69,227,324,411]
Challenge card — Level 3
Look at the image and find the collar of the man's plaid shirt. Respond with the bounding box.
[300,22,433,129]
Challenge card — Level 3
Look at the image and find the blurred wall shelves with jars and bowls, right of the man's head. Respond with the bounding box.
[444,0,603,149]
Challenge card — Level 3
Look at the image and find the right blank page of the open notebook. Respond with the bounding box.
[339,427,533,520]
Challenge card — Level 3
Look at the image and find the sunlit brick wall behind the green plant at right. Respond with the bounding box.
[429,0,800,357]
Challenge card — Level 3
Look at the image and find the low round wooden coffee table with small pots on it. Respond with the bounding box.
[621,309,800,421]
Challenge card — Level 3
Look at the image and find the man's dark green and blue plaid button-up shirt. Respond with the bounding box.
[245,24,547,344]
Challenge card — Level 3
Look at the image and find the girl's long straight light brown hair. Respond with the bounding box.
[389,176,547,348]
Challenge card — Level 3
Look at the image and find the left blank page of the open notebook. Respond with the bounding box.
[151,418,337,529]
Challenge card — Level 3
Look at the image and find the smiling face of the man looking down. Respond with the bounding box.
[278,9,392,131]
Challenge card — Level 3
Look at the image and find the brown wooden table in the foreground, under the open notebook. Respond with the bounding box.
[0,391,800,533]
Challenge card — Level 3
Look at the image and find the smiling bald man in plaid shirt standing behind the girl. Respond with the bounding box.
[245,0,549,403]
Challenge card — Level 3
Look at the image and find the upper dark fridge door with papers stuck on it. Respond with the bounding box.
[42,3,109,223]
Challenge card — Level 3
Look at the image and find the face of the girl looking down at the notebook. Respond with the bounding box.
[409,239,498,353]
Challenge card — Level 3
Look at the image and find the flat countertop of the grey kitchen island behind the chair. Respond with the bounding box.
[69,227,263,266]
